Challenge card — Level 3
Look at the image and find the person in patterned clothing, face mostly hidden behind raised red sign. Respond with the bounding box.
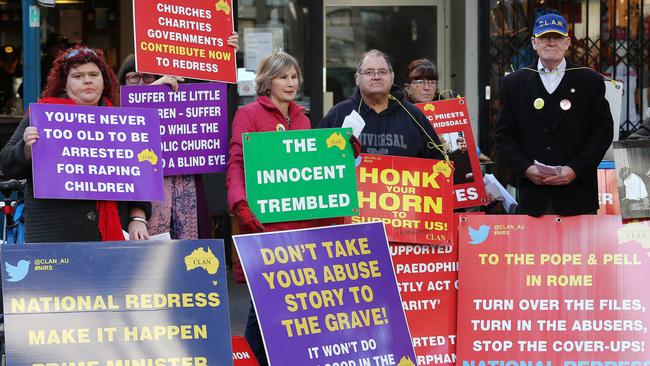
[117,32,239,239]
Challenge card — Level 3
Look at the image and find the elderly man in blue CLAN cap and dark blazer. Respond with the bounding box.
[496,14,614,216]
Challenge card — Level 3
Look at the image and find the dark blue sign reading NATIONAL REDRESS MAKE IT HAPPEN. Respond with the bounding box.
[0,240,233,366]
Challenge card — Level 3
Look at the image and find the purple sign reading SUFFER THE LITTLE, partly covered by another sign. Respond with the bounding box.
[120,83,228,175]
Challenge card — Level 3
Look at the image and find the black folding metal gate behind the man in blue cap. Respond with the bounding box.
[479,0,650,151]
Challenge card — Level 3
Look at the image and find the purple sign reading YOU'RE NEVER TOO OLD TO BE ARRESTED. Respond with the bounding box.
[29,104,164,201]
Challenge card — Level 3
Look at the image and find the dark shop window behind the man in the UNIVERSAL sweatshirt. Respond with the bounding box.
[325,4,440,104]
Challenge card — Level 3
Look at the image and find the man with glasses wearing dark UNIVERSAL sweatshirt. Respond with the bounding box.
[318,50,445,160]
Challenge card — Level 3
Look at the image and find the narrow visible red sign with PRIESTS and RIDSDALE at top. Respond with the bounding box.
[416,98,487,208]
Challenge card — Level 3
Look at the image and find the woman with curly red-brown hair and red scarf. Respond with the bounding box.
[0,46,151,243]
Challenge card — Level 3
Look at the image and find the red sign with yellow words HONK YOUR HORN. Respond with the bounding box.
[350,154,453,245]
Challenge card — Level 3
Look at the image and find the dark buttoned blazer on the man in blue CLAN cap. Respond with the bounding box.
[495,61,614,216]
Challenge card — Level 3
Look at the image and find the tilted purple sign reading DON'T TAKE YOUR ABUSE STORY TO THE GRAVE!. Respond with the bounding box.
[233,222,415,366]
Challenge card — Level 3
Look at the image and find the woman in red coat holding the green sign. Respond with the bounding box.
[226,52,352,366]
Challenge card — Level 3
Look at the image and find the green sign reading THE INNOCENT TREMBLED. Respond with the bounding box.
[243,128,359,223]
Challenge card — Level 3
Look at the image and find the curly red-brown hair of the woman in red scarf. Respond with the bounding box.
[42,45,119,105]
